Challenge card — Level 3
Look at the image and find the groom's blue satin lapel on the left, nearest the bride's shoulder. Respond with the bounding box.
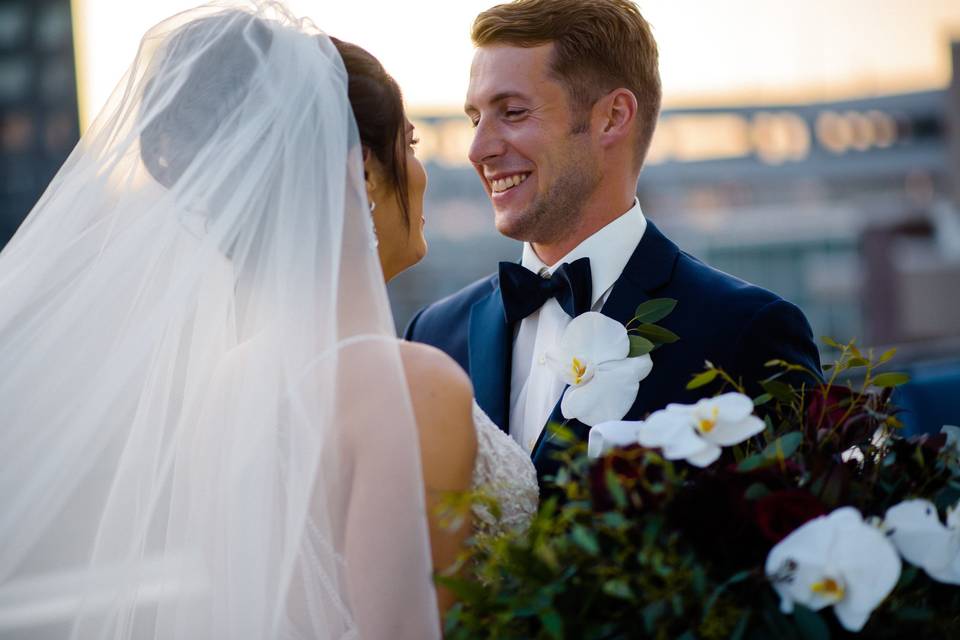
[467,280,513,433]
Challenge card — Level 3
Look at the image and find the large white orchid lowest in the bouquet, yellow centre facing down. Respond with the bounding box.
[766,507,901,632]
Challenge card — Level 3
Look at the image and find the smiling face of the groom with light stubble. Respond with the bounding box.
[464,44,599,244]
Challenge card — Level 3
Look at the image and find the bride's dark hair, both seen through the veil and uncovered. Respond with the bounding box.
[140,11,410,225]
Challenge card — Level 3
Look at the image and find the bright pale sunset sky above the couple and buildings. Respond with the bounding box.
[73,0,960,126]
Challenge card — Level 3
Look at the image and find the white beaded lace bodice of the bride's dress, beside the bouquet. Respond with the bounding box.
[473,402,540,535]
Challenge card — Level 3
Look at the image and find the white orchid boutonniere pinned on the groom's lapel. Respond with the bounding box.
[545,311,653,427]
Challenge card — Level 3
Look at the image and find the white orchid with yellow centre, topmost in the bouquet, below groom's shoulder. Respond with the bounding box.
[637,393,764,467]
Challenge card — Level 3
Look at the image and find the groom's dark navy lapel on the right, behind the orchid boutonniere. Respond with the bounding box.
[533,220,680,479]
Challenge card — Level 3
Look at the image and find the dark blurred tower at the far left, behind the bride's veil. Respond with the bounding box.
[0,0,79,247]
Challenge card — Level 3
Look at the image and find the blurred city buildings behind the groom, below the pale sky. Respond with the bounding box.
[391,44,960,344]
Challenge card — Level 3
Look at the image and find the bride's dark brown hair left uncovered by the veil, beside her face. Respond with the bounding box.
[330,37,410,226]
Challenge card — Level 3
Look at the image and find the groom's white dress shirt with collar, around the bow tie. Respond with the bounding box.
[510,200,647,452]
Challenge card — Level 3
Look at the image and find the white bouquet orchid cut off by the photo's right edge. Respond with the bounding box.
[883,500,960,584]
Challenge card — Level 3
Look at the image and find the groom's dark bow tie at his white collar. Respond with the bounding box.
[500,258,593,324]
